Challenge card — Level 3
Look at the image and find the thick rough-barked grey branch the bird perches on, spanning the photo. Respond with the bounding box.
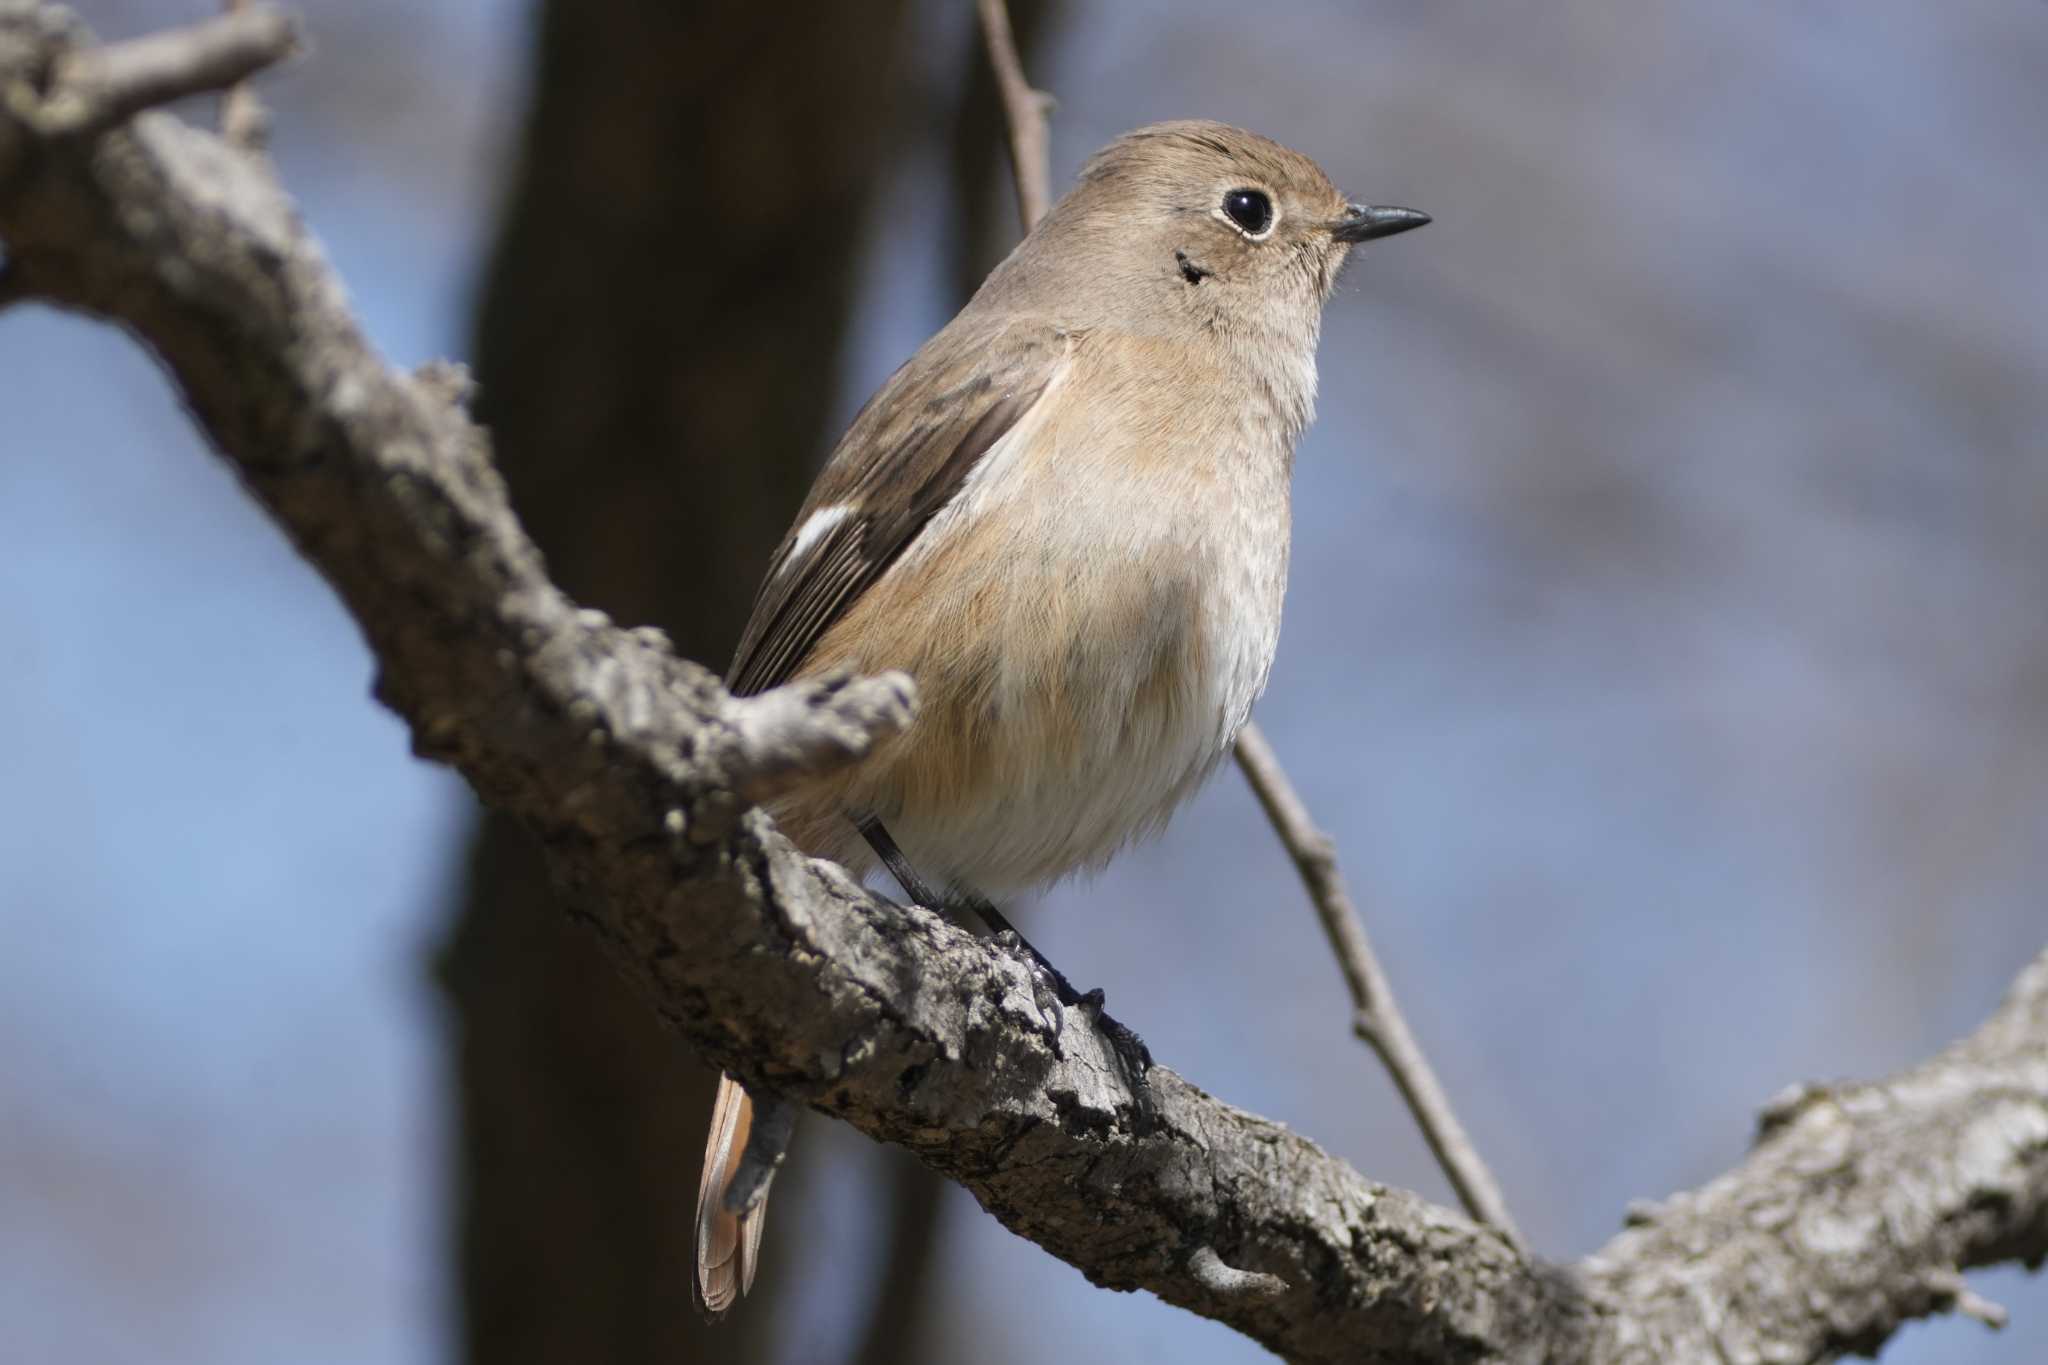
[0,0,2048,1361]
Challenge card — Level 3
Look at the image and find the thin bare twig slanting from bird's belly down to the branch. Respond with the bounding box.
[1237,722,1522,1246]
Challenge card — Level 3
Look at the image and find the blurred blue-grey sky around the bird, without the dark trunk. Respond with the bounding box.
[0,0,2048,1365]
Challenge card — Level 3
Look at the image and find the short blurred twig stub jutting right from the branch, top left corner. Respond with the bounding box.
[39,6,299,133]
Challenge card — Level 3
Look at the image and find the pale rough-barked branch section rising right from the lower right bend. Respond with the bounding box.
[1585,954,2048,1361]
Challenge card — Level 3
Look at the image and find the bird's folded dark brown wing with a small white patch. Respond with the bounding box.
[725,317,1069,696]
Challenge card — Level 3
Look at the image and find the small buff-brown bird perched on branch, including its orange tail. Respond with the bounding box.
[696,121,1430,1314]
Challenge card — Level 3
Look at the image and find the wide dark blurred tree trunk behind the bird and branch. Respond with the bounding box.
[442,0,909,1365]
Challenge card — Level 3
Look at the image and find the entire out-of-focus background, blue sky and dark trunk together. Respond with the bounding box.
[0,0,2048,1365]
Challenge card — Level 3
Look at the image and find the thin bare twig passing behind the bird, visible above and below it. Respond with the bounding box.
[981,0,1522,1248]
